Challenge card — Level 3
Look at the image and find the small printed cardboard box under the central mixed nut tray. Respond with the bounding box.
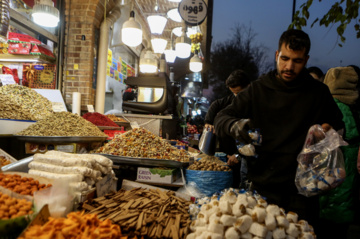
[137,167,181,184]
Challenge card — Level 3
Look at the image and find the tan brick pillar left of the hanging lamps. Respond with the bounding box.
[62,0,114,110]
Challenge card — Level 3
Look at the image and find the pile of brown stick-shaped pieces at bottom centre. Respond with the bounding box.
[82,188,191,239]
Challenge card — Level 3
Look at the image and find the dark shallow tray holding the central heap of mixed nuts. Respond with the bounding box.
[95,154,193,168]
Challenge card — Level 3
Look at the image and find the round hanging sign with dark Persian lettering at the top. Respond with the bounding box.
[178,0,207,26]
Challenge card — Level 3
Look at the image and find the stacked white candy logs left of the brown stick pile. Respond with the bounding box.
[29,151,115,193]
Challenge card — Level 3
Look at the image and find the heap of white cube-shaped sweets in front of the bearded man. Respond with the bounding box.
[186,191,316,239]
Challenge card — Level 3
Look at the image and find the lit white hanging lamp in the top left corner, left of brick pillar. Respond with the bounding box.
[31,0,59,27]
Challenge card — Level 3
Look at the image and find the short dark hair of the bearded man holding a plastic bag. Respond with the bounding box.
[278,29,311,55]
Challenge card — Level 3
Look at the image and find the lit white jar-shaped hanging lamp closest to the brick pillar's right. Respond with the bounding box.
[121,11,142,47]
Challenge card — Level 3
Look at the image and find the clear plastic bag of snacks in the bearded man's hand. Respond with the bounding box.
[295,125,348,197]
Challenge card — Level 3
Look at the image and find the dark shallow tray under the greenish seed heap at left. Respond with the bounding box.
[14,135,107,143]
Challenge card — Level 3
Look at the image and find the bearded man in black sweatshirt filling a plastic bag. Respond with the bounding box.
[215,29,344,233]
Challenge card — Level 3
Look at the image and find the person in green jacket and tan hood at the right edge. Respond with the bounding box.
[320,66,360,238]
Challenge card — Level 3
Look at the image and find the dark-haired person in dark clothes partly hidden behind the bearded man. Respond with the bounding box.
[205,70,250,188]
